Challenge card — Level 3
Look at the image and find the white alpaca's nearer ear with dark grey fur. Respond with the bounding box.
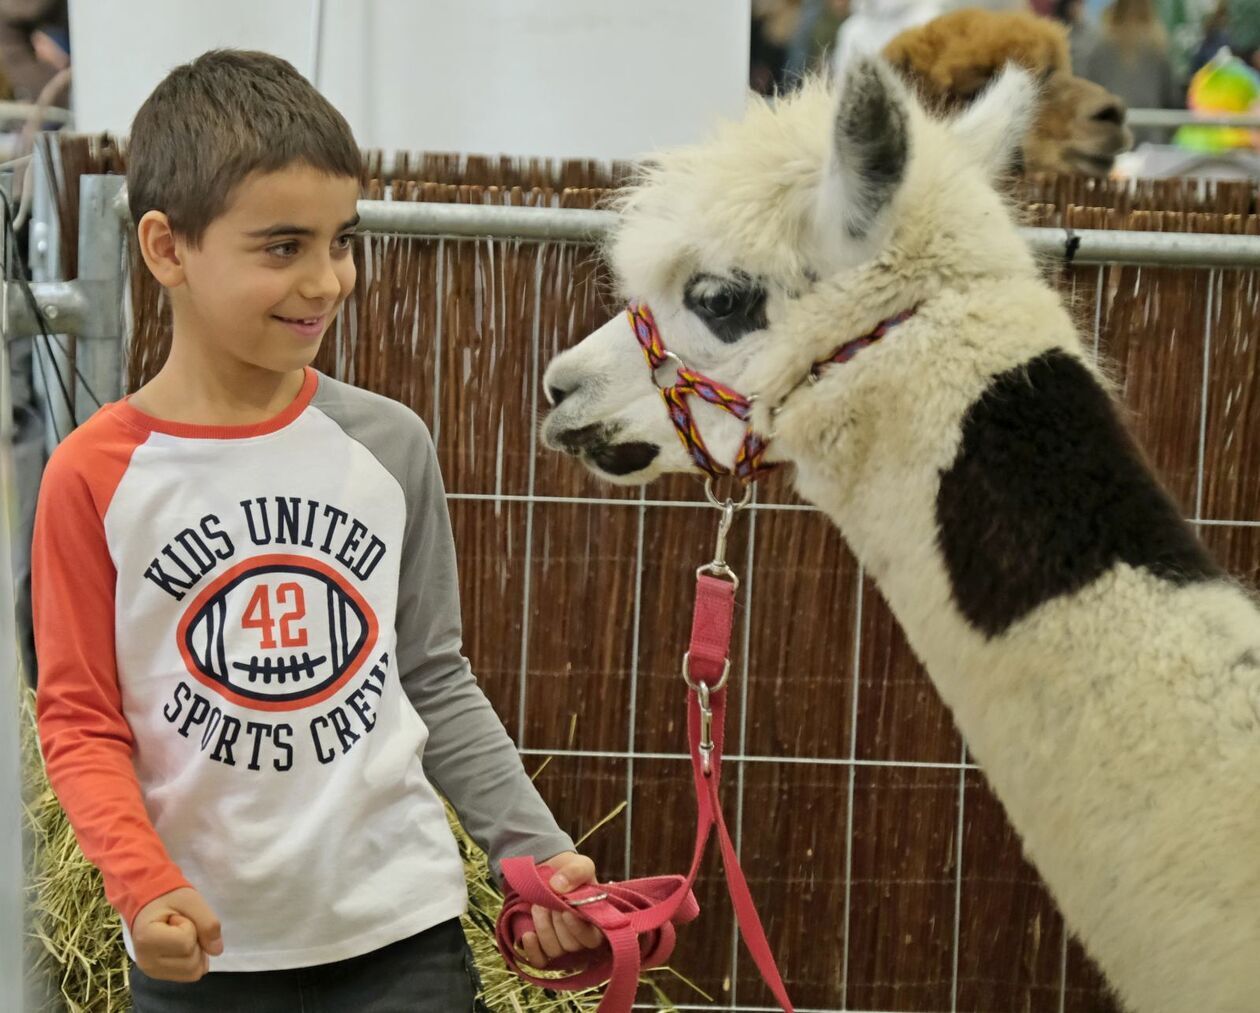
[820,58,910,239]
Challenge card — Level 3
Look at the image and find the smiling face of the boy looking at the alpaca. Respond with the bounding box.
[171,165,359,373]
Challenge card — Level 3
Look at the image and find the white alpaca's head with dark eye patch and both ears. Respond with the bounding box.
[543,59,1036,484]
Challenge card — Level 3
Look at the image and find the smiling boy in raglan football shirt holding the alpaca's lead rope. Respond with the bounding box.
[34,50,601,1013]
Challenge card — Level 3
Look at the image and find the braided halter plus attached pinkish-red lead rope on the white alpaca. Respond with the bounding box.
[498,304,915,1013]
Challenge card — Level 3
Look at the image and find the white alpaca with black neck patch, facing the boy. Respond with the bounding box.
[544,60,1260,1013]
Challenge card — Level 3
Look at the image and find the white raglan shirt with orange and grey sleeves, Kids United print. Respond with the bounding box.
[33,370,573,971]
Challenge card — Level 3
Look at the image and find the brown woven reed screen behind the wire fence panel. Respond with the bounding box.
[61,138,1260,1013]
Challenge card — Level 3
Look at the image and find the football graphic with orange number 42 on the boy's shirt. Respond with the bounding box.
[178,556,377,711]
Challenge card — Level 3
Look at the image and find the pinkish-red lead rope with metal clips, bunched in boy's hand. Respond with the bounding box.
[498,494,793,1013]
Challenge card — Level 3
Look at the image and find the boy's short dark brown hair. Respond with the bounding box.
[127,49,363,246]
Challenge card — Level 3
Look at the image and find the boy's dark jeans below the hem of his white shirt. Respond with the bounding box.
[131,919,475,1013]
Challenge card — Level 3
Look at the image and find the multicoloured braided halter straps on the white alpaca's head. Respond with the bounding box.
[626,302,915,484]
